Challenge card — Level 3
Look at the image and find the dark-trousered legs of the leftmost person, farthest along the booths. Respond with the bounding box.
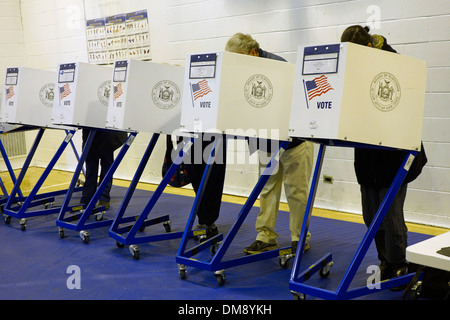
[80,129,127,210]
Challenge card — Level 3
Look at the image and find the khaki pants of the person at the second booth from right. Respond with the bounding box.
[255,141,314,244]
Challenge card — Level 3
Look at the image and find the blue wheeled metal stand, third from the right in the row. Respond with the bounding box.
[109,133,194,259]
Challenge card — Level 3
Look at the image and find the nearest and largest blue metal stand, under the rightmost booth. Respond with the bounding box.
[289,144,417,300]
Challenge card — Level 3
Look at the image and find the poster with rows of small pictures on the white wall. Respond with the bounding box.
[86,10,151,64]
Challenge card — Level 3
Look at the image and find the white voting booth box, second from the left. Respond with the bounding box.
[52,62,112,128]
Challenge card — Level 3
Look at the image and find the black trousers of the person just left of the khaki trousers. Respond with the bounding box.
[185,135,226,226]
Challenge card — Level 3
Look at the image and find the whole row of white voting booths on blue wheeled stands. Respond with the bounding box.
[1,43,426,299]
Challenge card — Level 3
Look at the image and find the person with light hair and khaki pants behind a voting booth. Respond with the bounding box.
[225,33,314,254]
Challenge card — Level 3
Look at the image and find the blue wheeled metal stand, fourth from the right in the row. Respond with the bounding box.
[56,129,137,243]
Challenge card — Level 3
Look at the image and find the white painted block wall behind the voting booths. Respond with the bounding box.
[0,0,450,227]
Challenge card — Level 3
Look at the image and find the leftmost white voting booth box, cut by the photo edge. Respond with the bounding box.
[1,67,61,127]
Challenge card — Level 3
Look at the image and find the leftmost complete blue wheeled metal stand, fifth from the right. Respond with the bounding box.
[3,128,81,231]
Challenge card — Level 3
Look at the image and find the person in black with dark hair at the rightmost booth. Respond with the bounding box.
[341,25,427,289]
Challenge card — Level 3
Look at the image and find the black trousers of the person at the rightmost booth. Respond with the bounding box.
[361,184,408,264]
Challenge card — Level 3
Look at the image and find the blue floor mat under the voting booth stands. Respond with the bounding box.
[0,186,430,300]
